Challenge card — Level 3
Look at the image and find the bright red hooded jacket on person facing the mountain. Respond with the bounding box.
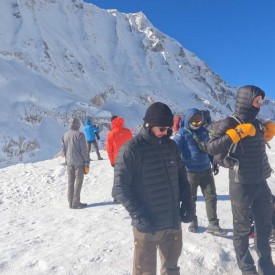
[106,117,133,165]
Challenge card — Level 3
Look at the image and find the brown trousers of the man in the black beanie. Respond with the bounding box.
[133,228,182,275]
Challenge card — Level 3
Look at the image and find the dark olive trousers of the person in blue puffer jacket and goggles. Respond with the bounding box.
[187,169,217,222]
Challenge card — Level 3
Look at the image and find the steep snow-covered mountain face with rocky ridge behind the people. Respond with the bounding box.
[0,0,274,167]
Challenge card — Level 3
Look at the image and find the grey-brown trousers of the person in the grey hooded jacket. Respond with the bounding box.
[67,165,84,206]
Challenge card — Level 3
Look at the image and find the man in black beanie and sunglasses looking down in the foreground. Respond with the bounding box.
[112,102,194,275]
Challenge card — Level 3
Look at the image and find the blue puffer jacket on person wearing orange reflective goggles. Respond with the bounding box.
[174,108,211,172]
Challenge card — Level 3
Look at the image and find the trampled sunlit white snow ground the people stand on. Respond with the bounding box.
[0,141,275,275]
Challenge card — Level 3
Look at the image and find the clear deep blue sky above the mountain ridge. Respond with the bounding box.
[86,0,275,99]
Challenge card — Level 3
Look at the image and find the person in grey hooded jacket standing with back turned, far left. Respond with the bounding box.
[62,118,90,209]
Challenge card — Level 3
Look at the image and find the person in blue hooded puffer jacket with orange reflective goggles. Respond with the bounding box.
[174,108,227,236]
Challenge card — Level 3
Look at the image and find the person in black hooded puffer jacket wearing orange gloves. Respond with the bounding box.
[207,86,275,275]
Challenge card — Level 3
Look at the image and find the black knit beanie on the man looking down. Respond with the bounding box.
[143,102,173,127]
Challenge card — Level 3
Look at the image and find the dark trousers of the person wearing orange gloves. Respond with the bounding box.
[229,181,273,274]
